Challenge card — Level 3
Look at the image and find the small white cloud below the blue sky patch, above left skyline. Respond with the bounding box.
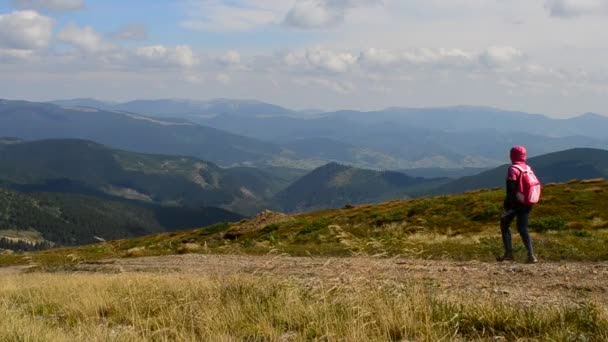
[135,45,199,68]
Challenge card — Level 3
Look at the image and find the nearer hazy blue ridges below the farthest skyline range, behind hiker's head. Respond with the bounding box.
[201,112,608,169]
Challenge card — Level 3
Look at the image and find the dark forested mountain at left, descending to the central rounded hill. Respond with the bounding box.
[0,139,296,214]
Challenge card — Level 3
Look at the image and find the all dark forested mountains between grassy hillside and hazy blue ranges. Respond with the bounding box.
[0,138,608,245]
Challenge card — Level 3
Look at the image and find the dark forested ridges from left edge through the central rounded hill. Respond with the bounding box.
[0,138,446,215]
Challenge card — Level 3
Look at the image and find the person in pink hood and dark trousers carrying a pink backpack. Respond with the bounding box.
[497,146,540,264]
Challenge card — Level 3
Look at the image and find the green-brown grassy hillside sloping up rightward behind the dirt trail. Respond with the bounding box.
[0,180,608,264]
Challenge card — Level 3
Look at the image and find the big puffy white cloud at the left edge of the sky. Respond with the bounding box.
[0,11,54,50]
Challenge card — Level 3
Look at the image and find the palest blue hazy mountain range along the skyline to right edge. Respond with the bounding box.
[45,99,608,170]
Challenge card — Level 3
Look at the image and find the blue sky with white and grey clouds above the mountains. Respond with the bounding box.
[0,0,608,117]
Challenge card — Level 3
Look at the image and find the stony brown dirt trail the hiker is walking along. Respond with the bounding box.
[76,254,608,306]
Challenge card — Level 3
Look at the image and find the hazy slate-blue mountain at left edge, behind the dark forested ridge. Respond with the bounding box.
[0,100,287,166]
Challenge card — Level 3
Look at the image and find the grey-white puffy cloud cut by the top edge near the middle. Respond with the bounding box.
[283,0,382,29]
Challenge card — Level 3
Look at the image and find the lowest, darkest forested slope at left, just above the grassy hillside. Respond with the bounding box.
[0,188,242,246]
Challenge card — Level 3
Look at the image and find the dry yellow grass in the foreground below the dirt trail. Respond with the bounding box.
[0,272,608,341]
